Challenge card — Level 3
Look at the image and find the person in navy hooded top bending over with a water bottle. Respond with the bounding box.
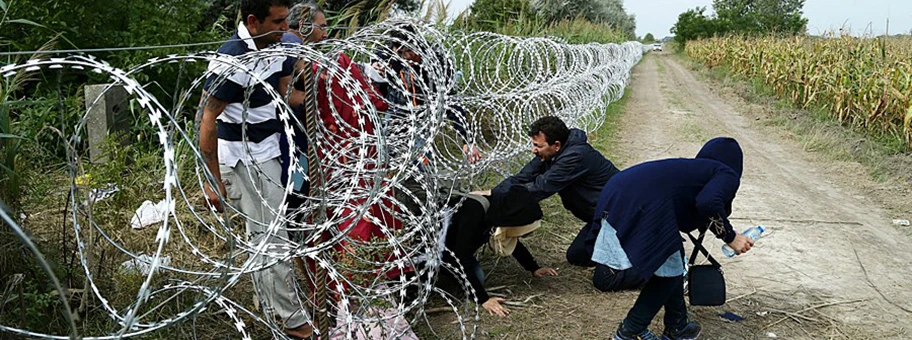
[592,138,753,340]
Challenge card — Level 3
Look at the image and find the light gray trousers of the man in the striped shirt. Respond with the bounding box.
[219,158,310,328]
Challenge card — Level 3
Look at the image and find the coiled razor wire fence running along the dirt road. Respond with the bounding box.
[0,19,644,339]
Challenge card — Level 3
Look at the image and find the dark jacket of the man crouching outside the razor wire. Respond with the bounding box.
[492,129,618,222]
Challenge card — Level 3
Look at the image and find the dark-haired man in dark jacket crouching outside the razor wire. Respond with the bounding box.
[492,116,618,267]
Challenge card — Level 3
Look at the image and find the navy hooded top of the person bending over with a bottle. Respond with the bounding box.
[587,138,743,278]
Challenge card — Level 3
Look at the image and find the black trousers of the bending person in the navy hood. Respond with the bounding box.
[624,275,687,333]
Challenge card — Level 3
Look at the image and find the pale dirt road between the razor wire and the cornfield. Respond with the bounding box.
[424,54,912,339]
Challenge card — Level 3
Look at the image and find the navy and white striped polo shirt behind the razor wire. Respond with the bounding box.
[204,23,294,167]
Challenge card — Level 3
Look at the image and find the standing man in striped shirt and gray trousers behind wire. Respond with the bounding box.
[200,0,313,338]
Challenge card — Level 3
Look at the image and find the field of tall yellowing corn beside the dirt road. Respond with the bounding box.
[685,36,912,148]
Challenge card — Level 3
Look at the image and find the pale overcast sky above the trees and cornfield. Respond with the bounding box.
[440,0,912,38]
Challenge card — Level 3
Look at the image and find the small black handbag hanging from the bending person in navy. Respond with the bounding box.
[687,230,725,306]
